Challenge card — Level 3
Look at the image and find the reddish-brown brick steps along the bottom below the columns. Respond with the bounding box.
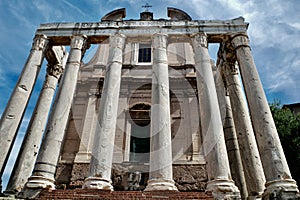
[37,189,213,200]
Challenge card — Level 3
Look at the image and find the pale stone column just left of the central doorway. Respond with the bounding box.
[83,34,125,190]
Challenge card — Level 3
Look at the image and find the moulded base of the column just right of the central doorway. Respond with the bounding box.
[144,179,178,192]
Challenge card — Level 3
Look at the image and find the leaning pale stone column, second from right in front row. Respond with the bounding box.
[192,33,240,199]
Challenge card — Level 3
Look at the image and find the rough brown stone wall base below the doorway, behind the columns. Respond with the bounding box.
[56,163,207,191]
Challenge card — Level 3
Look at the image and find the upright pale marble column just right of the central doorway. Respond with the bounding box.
[145,33,177,191]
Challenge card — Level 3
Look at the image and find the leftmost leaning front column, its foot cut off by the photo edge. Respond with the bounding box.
[0,35,48,185]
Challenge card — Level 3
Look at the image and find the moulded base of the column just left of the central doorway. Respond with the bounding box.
[82,177,114,191]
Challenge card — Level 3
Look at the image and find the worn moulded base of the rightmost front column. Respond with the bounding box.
[262,179,300,200]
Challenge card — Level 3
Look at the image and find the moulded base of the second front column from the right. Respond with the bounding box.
[206,179,241,200]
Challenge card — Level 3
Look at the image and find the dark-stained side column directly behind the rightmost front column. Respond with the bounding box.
[222,45,266,199]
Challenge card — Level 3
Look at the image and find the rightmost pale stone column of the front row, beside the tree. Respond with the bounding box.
[231,34,298,199]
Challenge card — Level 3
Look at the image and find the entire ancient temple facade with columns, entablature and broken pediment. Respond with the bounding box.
[0,8,298,199]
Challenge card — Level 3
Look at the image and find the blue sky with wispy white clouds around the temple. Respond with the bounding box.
[0,0,300,191]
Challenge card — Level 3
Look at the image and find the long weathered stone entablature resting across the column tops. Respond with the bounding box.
[36,17,249,45]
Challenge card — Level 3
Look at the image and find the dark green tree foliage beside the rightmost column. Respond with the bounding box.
[270,102,300,184]
